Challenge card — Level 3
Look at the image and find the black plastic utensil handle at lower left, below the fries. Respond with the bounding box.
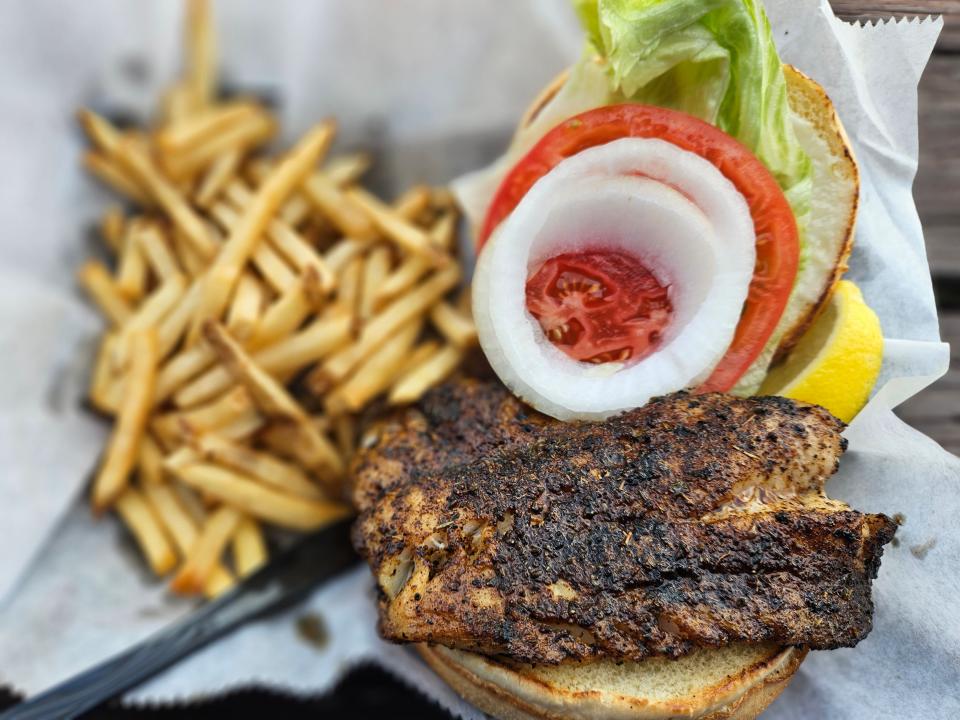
[0,519,357,720]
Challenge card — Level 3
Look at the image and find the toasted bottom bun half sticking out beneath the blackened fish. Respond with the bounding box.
[418,645,806,720]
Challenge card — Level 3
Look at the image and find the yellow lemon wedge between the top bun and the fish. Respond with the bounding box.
[760,280,883,422]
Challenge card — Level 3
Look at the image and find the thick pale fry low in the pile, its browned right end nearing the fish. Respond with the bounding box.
[177,464,350,530]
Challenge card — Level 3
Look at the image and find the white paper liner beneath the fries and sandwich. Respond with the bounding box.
[0,0,960,720]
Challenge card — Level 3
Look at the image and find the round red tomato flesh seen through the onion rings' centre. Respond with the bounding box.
[526,250,673,363]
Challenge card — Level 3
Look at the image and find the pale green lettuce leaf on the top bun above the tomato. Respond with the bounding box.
[573,0,813,233]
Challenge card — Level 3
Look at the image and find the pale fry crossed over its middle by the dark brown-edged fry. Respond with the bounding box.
[173,315,352,407]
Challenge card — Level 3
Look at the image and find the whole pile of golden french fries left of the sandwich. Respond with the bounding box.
[79,0,476,597]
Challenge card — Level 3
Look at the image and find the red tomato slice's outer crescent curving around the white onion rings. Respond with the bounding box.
[477,104,800,392]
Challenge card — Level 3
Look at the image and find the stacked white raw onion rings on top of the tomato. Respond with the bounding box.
[473,138,756,420]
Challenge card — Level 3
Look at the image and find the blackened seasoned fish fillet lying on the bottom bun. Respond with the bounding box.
[354,384,895,663]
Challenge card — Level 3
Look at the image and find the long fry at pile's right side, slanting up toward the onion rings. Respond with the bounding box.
[314,263,460,387]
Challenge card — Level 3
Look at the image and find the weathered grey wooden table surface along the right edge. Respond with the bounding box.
[831,0,960,455]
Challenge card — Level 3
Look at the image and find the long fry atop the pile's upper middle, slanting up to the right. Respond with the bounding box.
[194,122,333,333]
